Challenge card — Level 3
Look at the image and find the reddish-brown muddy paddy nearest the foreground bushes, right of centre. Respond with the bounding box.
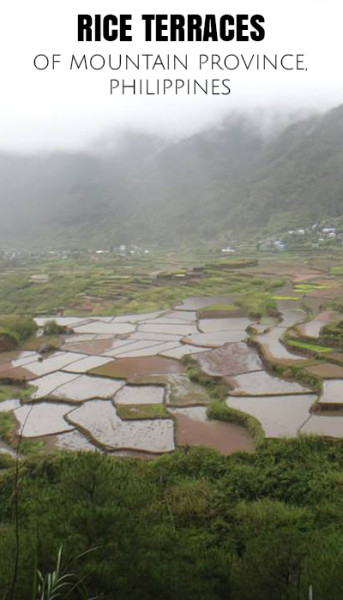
[175,414,255,454]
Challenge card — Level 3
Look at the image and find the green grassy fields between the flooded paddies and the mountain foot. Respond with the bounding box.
[0,250,282,316]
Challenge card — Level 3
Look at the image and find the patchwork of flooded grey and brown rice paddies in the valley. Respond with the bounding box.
[0,297,343,455]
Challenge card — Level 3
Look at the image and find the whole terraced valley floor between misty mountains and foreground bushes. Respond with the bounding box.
[0,250,343,458]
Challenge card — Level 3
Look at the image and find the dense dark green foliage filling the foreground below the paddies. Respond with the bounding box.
[0,438,343,600]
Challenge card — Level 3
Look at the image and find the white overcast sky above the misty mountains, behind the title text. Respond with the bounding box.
[0,0,343,151]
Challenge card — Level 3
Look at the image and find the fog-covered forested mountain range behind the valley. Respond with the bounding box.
[0,106,343,246]
